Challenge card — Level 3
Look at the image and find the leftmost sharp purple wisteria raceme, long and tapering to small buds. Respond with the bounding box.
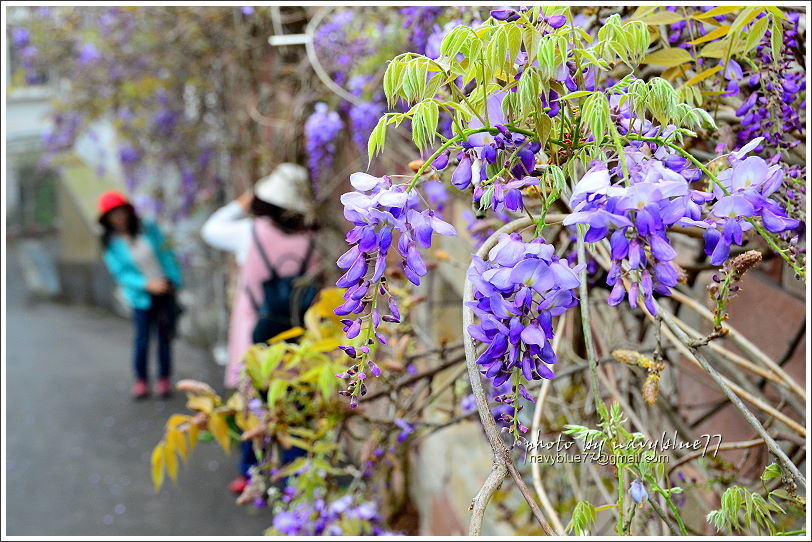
[335,172,457,406]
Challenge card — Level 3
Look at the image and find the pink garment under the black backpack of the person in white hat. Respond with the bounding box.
[225,217,317,388]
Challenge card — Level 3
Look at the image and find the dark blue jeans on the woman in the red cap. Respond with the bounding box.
[133,294,177,380]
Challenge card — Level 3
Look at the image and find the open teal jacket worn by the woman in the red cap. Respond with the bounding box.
[104,221,183,309]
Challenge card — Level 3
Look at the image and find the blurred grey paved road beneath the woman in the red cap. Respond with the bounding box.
[3,246,272,536]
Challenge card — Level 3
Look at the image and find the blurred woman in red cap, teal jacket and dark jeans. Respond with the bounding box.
[98,191,183,399]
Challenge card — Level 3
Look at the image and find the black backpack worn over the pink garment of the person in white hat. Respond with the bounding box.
[246,230,319,344]
